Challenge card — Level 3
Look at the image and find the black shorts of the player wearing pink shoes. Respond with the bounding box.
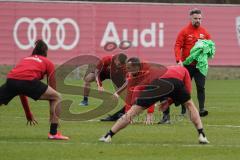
[0,79,48,105]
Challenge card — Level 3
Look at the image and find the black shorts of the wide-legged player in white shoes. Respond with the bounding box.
[135,78,191,108]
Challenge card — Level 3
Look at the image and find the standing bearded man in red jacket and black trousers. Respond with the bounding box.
[174,8,211,117]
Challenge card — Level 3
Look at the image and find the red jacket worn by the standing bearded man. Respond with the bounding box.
[174,23,211,62]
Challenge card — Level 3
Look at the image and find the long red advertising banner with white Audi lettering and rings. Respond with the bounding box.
[0,2,240,66]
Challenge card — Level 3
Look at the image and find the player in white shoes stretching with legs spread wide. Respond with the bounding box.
[99,58,209,144]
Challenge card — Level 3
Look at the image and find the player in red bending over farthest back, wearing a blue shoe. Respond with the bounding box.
[79,53,127,106]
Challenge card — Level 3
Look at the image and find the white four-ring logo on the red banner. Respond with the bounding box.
[13,17,80,50]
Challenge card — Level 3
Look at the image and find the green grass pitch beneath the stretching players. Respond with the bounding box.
[0,80,240,160]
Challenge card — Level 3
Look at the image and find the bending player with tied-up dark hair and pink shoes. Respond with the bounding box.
[0,40,69,140]
